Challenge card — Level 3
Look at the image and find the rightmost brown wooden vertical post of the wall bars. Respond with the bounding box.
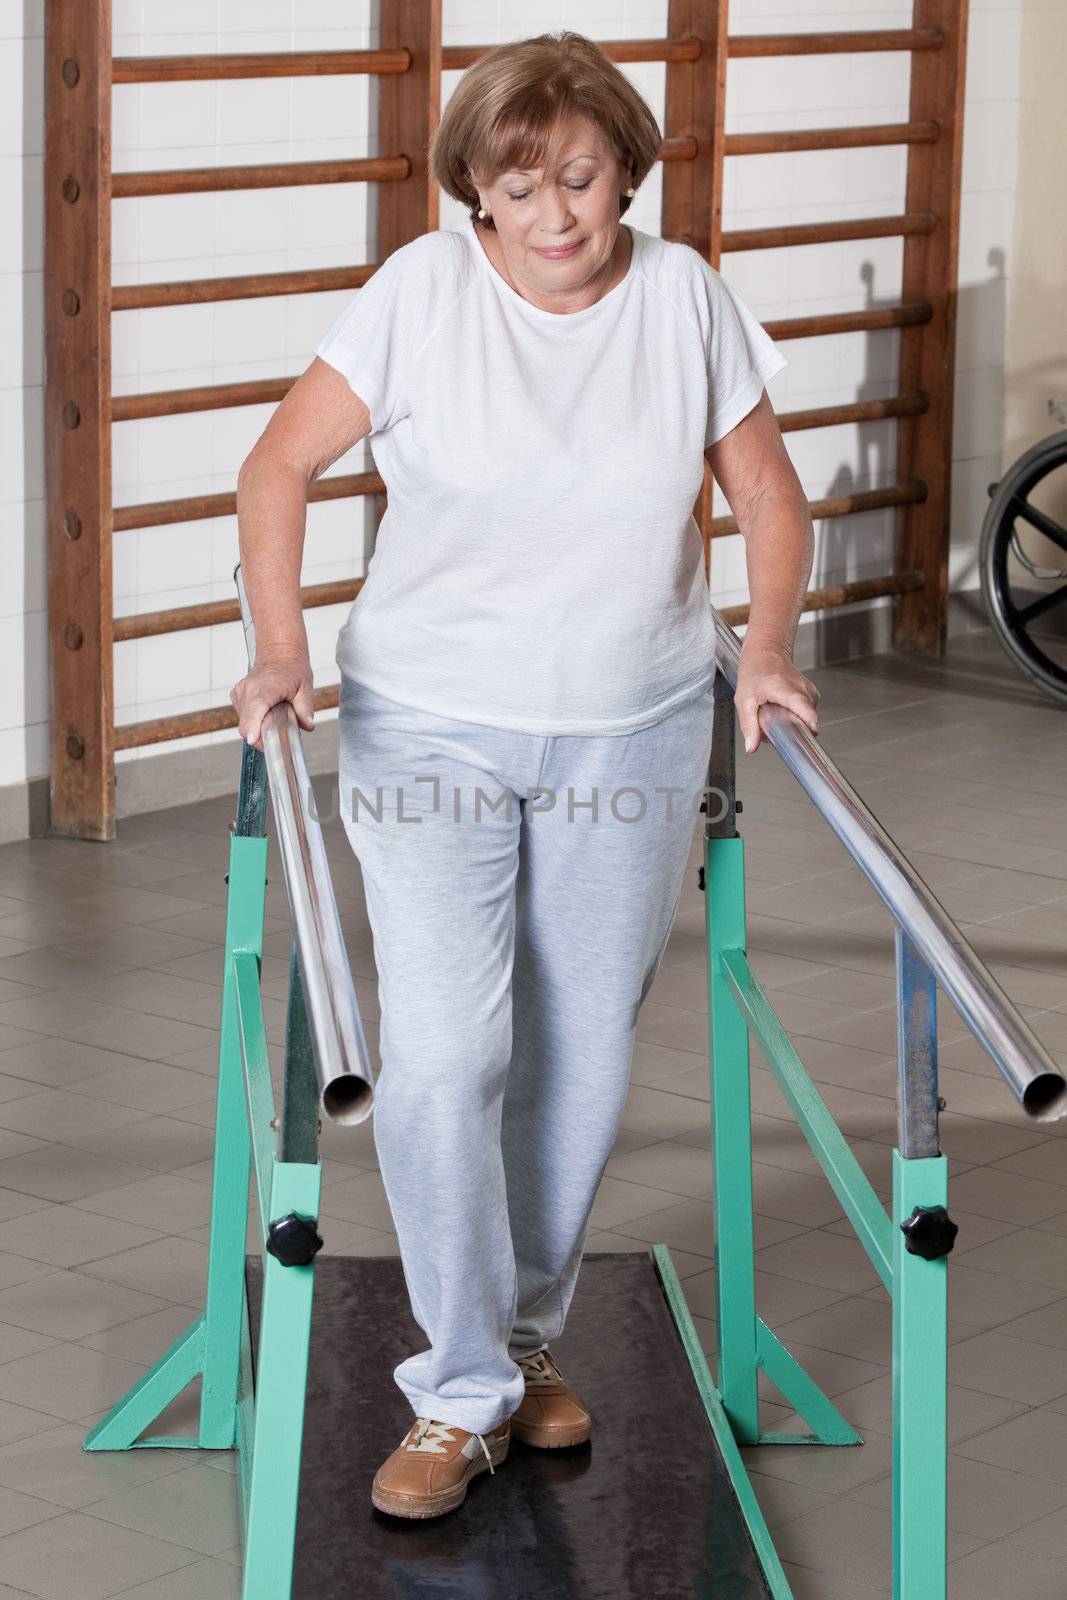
[893,0,968,654]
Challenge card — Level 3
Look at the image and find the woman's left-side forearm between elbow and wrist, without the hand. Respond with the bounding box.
[237,451,307,659]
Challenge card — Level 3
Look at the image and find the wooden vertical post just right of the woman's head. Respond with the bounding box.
[661,0,729,574]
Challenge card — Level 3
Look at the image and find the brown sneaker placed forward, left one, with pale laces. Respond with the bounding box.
[371,1416,510,1517]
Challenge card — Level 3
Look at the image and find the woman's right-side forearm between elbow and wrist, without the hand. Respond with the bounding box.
[742,483,814,658]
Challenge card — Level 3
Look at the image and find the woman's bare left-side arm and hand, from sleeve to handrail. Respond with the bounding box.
[230,357,371,749]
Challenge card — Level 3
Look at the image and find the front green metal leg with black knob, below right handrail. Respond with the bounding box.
[893,1150,949,1600]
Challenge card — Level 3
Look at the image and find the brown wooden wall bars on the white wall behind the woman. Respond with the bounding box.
[45,0,966,838]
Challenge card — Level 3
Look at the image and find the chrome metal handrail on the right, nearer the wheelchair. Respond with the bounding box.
[712,606,1067,1122]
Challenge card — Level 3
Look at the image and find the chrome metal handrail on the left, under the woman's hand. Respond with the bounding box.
[234,563,374,1123]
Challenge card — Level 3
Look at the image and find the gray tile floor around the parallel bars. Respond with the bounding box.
[0,634,1067,1600]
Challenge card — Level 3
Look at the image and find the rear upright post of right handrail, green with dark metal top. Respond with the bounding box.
[704,672,760,1445]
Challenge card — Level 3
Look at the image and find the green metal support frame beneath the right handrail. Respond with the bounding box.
[653,834,949,1600]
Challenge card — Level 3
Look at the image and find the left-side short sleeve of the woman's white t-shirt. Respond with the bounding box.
[315,235,432,434]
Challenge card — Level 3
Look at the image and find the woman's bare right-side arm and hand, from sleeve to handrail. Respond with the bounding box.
[705,390,819,750]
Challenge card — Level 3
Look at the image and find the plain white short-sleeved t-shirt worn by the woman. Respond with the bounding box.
[315,219,785,734]
